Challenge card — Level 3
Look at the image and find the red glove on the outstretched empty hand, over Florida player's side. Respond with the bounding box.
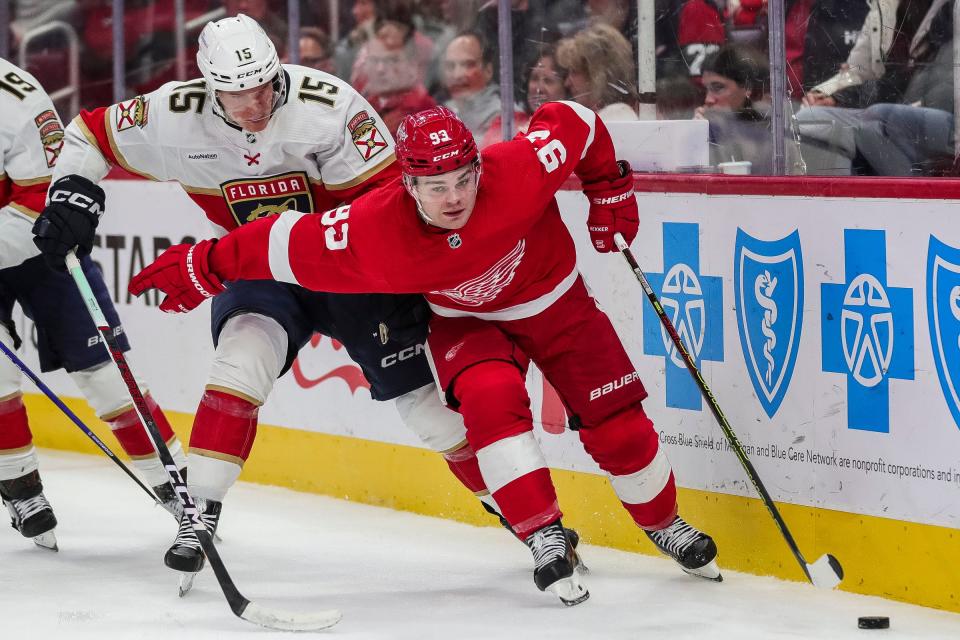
[127,240,226,313]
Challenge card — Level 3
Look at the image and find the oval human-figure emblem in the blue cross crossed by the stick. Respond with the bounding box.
[660,264,706,367]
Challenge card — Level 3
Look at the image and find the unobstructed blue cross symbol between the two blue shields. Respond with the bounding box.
[820,229,914,433]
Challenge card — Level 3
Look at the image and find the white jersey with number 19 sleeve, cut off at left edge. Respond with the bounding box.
[0,58,63,269]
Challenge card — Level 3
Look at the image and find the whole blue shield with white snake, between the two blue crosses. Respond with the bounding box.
[733,229,803,418]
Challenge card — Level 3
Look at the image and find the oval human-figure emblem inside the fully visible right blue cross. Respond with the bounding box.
[840,273,893,387]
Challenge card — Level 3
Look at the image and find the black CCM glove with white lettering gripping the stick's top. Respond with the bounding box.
[33,175,106,271]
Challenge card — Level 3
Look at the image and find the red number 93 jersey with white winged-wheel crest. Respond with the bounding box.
[211,102,619,320]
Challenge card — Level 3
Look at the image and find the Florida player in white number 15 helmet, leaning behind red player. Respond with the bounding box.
[35,15,556,584]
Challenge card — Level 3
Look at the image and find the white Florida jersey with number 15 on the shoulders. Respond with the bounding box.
[55,65,399,235]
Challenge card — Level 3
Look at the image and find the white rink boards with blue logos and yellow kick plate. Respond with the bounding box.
[21,176,960,610]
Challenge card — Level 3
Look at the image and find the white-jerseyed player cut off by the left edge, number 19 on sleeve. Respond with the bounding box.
[0,58,186,549]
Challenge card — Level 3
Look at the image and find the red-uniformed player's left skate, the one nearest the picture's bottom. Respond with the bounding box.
[524,520,590,607]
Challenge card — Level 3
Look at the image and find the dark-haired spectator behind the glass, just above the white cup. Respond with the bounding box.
[694,44,773,174]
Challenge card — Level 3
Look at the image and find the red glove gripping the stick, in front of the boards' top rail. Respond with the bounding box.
[583,160,640,253]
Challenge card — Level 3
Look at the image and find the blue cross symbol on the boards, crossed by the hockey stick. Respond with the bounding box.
[643,222,723,411]
